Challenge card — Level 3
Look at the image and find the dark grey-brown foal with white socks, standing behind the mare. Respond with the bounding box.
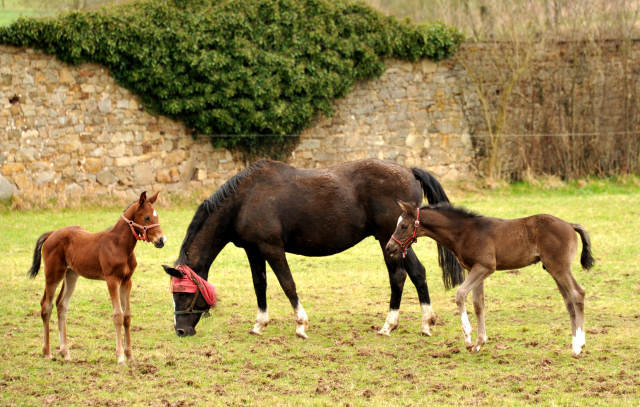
[386,200,595,357]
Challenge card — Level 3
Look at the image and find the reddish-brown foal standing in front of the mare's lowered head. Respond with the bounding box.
[28,192,167,363]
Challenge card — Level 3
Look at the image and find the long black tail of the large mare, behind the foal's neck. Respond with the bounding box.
[411,167,465,289]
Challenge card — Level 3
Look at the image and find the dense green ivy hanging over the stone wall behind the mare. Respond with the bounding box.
[0,0,462,156]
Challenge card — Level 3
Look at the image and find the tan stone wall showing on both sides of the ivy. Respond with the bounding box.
[0,46,474,199]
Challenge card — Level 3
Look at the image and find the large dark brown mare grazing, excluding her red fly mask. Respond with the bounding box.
[163,159,464,339]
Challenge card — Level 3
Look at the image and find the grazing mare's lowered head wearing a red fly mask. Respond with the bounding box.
[162,265,217,336]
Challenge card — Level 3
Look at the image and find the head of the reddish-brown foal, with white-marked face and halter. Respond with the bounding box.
[122,191,167,248]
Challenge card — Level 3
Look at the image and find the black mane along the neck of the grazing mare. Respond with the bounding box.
[176,160,267,264]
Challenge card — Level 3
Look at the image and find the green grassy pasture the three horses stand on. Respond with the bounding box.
[0,182,640,406]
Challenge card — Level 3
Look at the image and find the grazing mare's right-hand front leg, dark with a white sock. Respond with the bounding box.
[261,246,309,339]
